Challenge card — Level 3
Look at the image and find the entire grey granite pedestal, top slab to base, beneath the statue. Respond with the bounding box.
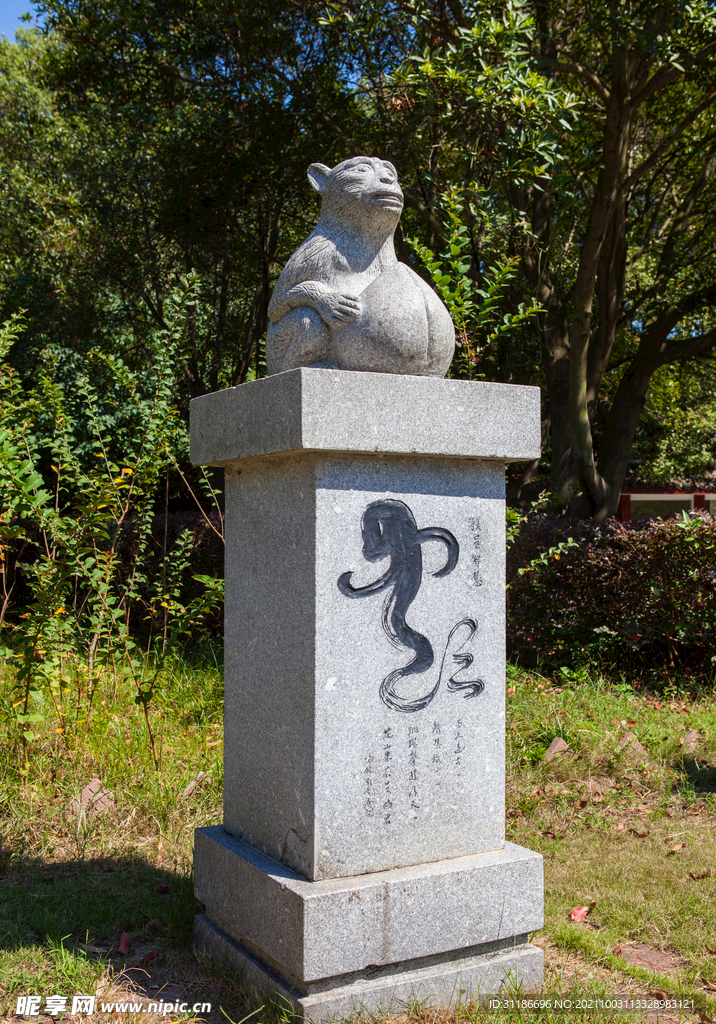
[192,368,542,1019]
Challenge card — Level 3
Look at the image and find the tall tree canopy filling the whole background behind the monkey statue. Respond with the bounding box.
[0,0,716,518]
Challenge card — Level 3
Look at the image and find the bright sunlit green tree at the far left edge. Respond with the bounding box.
[0,29,96,376]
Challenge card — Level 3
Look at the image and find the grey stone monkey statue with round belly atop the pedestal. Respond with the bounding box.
[266,157,455,377]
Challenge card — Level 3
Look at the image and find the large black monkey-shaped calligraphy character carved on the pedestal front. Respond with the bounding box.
[338,498,485,712]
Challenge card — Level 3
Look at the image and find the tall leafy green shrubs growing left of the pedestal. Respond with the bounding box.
[0,282,222,765]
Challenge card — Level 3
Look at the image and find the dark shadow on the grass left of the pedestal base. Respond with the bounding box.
[0,853,198,949]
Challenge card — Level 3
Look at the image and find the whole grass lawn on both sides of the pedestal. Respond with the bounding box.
[0,664,716,1024]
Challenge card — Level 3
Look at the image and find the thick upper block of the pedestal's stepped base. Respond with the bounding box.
[195,825,543,983]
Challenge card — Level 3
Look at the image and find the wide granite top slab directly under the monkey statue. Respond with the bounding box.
[189,367,540,466]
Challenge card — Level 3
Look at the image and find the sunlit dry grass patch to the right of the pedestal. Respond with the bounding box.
[508,675,716,1014]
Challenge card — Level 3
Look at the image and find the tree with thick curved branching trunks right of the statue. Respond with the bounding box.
[332,0,716,519]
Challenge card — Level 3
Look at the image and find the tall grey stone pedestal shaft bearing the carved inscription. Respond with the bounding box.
[224,453,505,880]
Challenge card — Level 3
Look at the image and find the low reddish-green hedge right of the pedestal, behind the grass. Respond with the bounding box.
[508,512,716,681]
